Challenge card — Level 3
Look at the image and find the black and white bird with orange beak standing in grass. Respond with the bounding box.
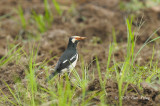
[46,36,86,81]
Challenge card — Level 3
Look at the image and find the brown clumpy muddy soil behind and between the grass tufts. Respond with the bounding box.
[0,0,160,106]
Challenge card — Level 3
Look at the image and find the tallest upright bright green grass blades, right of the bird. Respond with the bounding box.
[117,19,135,106]
